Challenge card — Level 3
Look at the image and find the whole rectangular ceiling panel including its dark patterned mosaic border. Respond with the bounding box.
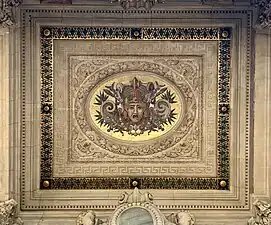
[40,27,232,190]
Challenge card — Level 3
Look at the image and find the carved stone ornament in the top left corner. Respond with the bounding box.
[0,0,22,27]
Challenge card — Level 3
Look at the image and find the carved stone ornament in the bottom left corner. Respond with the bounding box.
[0,199,23,225]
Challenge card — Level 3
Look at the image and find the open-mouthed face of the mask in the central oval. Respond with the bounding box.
[126,102,146,123]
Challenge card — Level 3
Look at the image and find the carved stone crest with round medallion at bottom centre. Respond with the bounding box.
[76,188,195,225]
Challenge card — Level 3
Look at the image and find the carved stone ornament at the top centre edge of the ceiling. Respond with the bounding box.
[110,0,166,10]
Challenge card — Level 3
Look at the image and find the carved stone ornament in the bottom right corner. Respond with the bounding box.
[248,200,271,225]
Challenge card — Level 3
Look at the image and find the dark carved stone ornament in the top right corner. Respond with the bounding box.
[253,0,271,28]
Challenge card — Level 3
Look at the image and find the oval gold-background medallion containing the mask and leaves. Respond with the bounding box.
[87,71,183,142]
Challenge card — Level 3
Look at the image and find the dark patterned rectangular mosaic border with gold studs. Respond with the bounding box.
[40,27,231,190]
